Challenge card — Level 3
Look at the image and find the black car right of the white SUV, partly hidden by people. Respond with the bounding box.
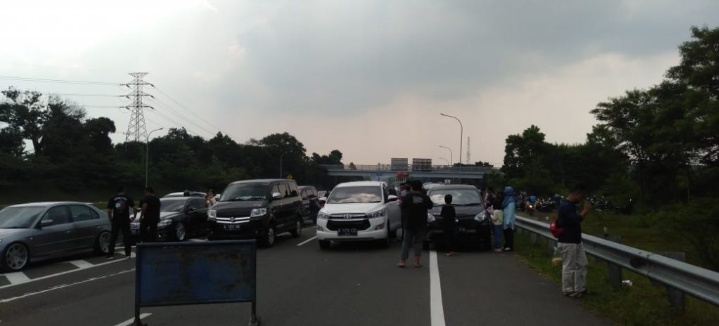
[426,185,492,250]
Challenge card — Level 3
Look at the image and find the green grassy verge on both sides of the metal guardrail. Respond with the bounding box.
[516,212,719,325]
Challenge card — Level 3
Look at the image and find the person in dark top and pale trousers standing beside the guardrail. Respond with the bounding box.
[557,184,591,298]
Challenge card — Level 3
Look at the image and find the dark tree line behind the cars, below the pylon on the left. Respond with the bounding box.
[0,87,342,200]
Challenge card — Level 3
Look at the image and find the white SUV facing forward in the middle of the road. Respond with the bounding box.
[317,181,401,249]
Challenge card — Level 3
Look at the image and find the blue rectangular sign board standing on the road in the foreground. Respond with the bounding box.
[135,240,257,324]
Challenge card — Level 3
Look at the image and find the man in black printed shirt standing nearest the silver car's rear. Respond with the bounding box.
[107,187,137,259]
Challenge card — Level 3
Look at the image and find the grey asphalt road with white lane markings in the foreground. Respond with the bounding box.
[0,228,609,326]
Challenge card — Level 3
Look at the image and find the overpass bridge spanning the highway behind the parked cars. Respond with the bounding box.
[322,164,493,181]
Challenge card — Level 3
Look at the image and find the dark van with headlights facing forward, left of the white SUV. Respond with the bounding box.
[207,179,302,247]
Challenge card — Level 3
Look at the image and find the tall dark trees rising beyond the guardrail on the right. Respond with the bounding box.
[486,27,719,270]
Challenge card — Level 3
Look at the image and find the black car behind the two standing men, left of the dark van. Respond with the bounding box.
[130,196,207,241]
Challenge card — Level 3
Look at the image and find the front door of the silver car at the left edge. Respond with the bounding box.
[33,205,76,257]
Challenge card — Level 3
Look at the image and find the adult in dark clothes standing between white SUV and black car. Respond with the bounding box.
[397,180,434,268]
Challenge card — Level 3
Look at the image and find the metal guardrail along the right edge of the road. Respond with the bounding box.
[516,216,719,306]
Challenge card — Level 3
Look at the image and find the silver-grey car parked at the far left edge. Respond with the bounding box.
[0,202,111,271]
